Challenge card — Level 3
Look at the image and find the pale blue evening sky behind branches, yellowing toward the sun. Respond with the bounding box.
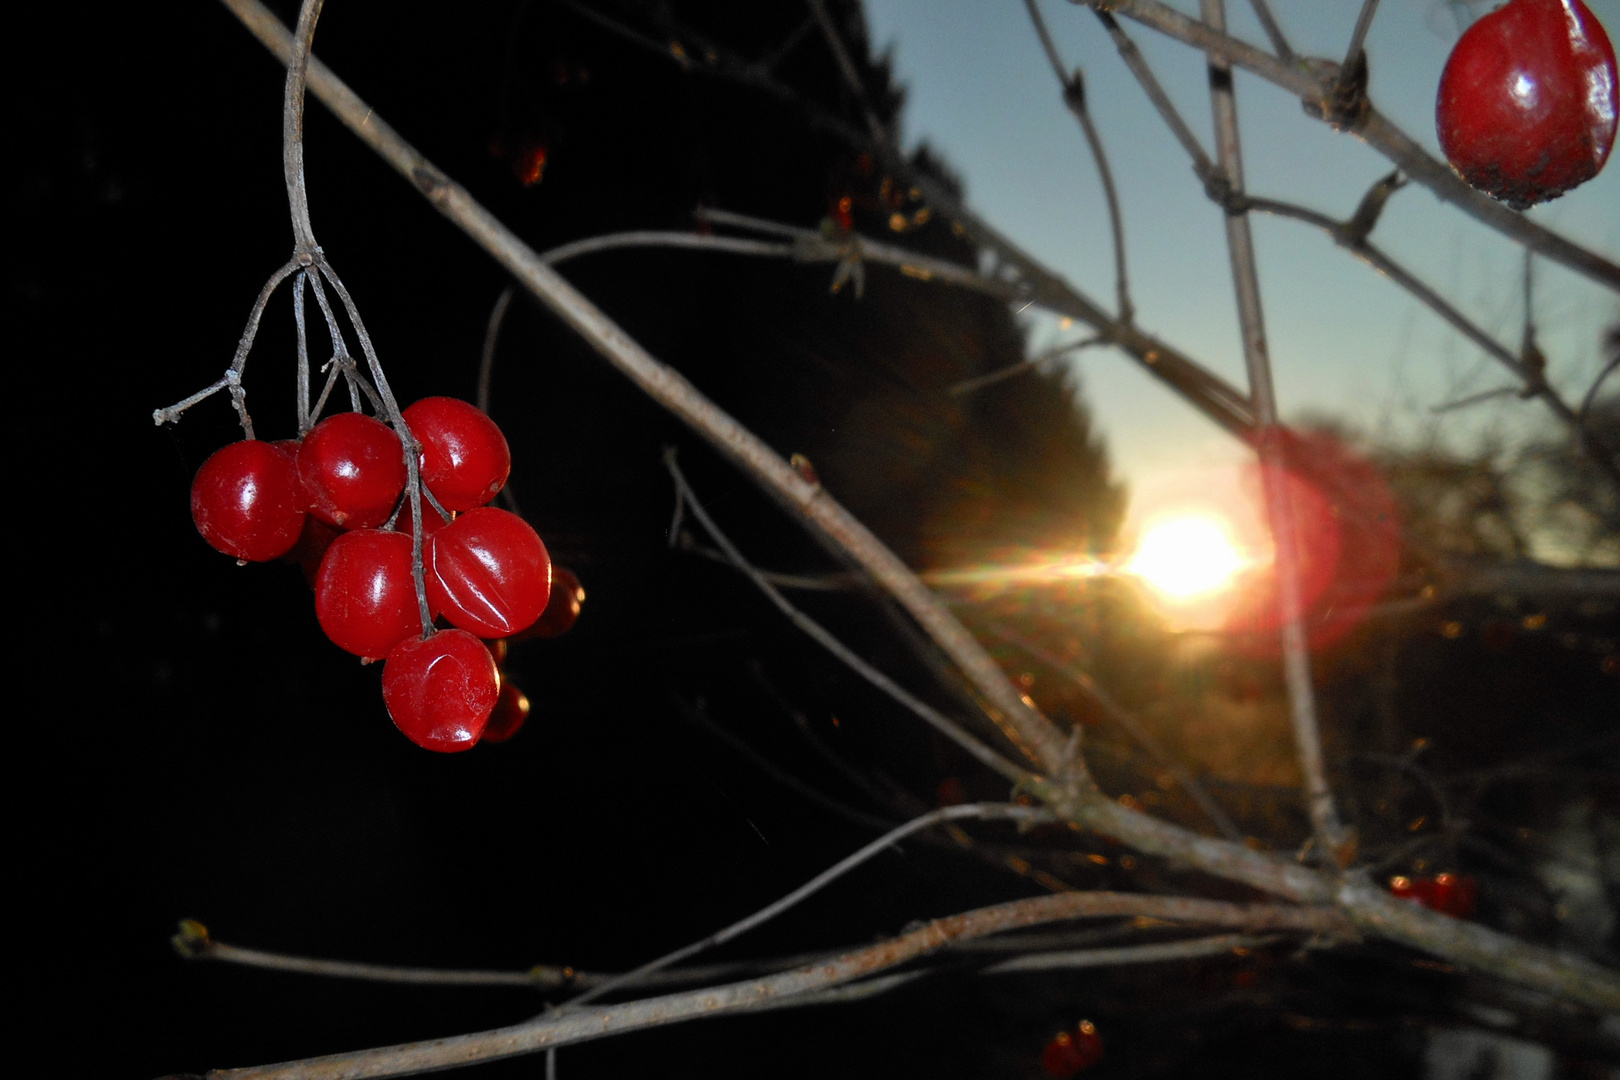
[867,0,1620,540]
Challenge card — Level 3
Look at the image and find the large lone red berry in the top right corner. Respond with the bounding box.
[1435,0,1617,210]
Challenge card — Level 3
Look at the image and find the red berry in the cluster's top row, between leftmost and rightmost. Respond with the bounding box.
[298,413,405,529]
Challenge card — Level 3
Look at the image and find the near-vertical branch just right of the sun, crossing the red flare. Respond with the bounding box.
[1200,0,1353,865]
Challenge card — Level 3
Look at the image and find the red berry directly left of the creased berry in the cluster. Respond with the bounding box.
[314,529,421,657]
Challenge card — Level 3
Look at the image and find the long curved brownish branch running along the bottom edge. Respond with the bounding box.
[209,892,1354,1080]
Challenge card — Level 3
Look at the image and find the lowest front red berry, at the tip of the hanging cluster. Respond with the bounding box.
[382,630,501,753]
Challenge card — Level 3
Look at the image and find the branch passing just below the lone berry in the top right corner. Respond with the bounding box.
[1084,0,1620,290]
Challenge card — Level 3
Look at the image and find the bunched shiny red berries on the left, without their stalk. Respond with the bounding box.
[191,397,585,751]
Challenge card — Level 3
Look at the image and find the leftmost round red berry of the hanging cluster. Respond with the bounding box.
[191,439,305,562]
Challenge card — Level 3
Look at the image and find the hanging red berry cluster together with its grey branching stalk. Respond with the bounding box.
[152,0,585,753]
